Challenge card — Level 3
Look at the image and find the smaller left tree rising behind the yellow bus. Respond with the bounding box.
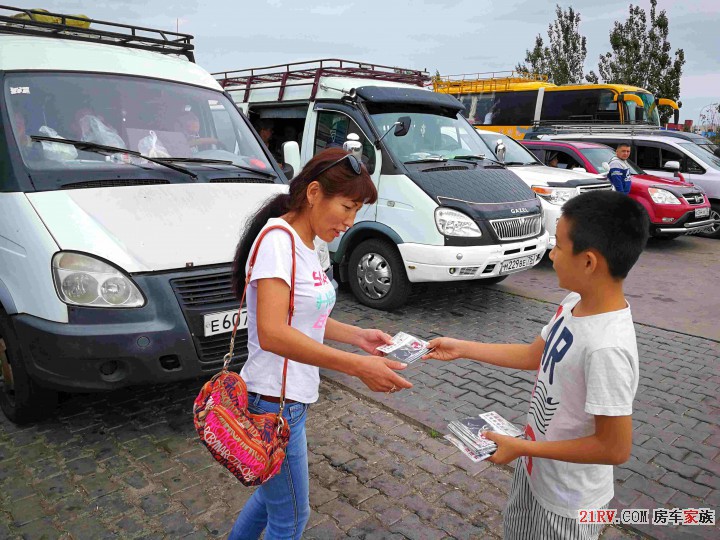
[515,5,587,84]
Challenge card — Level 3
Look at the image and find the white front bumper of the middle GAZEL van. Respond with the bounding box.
[397,232,549,283]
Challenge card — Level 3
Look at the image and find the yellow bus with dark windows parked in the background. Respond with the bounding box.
[433,71,678,139]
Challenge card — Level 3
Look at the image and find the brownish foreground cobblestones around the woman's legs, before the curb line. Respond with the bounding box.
[0,381,632,540]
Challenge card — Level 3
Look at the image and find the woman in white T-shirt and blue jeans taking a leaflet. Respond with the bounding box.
[229,148,412,540]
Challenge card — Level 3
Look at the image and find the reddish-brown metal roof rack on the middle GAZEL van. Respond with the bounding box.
[213,58,430,102]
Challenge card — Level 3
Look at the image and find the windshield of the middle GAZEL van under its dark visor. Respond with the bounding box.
[371,107,495,163]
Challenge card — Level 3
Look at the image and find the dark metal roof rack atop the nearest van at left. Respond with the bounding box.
[0,5,195,62]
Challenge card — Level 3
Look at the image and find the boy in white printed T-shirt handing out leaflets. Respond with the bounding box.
[424,191,648,540]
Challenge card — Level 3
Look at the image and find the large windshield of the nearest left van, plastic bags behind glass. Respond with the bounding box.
[4,73,272,182]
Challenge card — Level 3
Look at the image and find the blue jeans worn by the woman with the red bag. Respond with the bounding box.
[228,393,310,540]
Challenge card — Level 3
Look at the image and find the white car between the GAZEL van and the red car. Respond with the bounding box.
[475,128,613,249]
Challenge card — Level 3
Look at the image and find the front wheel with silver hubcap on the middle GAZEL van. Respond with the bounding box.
[348,238,411,311]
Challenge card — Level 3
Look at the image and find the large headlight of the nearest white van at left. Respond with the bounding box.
[52,251,145,308]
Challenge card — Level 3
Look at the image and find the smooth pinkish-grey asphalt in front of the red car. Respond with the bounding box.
[497,236,720,341]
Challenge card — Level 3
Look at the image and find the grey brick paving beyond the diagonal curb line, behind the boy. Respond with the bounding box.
[326,283,720,539]
